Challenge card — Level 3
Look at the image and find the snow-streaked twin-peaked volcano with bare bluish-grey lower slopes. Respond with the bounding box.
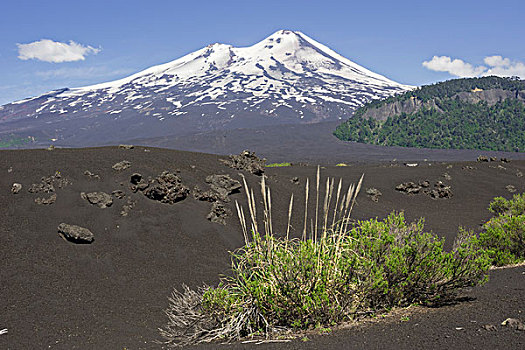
[0,30,412,146]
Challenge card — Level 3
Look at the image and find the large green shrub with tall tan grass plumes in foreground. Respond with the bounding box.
[161,168,489,345]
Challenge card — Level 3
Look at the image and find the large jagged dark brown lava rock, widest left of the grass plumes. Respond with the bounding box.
[131,171,190,204]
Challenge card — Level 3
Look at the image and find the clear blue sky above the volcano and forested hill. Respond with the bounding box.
[0,0,525,104]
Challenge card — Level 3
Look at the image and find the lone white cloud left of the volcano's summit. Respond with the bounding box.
[16,39,100,63]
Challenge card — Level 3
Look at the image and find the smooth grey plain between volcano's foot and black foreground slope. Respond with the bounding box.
[129,122,525,164]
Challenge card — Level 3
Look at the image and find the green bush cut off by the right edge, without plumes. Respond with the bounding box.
[479,193,525,266]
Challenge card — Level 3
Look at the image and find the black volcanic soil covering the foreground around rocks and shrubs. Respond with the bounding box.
[0,147,525,349]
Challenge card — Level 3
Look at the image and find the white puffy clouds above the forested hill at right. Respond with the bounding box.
[423,55,525,79]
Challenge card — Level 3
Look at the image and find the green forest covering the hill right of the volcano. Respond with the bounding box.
[334,77,525,152]
